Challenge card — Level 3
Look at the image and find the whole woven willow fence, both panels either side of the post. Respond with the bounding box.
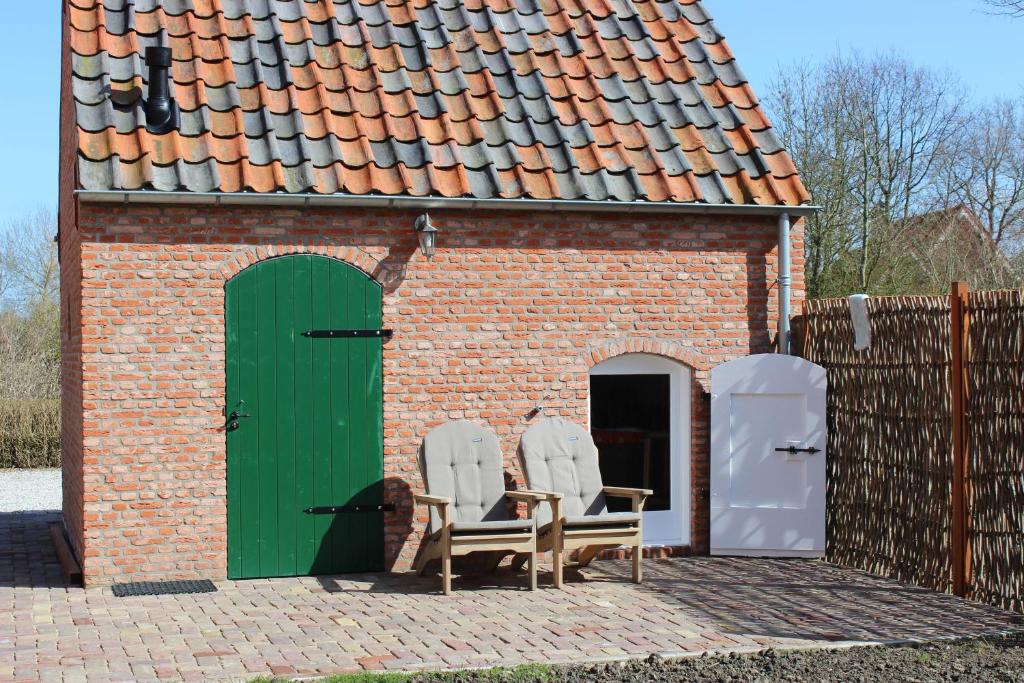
[798,292,1024,612]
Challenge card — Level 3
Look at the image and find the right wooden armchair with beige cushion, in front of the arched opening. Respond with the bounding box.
[519,418,653,588]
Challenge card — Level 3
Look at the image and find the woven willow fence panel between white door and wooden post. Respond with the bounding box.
[803,297,952,591]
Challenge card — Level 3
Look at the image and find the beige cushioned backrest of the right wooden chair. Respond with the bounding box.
[519,418,608,524]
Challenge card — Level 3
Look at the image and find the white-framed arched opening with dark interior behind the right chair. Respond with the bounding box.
[590,353,691,546]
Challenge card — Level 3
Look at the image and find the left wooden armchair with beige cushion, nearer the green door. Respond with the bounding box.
[414,420,544,595]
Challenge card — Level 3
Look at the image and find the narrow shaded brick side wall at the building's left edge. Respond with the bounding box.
[57,0,85,557]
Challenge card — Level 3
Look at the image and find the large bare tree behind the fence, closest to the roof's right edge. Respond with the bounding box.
[768,54,965,296]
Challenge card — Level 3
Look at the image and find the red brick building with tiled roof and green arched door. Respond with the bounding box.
[59,0,810,584]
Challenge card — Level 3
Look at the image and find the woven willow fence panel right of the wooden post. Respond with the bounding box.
[967,292,1024,612]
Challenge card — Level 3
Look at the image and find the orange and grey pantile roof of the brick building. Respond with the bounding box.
[68,0,809,206]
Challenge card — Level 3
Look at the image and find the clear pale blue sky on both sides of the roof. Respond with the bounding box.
[0,0,1024,224]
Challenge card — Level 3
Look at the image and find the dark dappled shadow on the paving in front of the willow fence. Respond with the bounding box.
[585,557,1024,642]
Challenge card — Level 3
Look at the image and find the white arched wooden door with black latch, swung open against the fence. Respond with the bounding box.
[711,354,826,557]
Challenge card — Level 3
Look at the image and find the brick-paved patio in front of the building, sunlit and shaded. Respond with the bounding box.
[0,513,1021,681]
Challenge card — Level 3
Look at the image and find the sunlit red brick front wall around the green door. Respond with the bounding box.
[67,205,803,583]
